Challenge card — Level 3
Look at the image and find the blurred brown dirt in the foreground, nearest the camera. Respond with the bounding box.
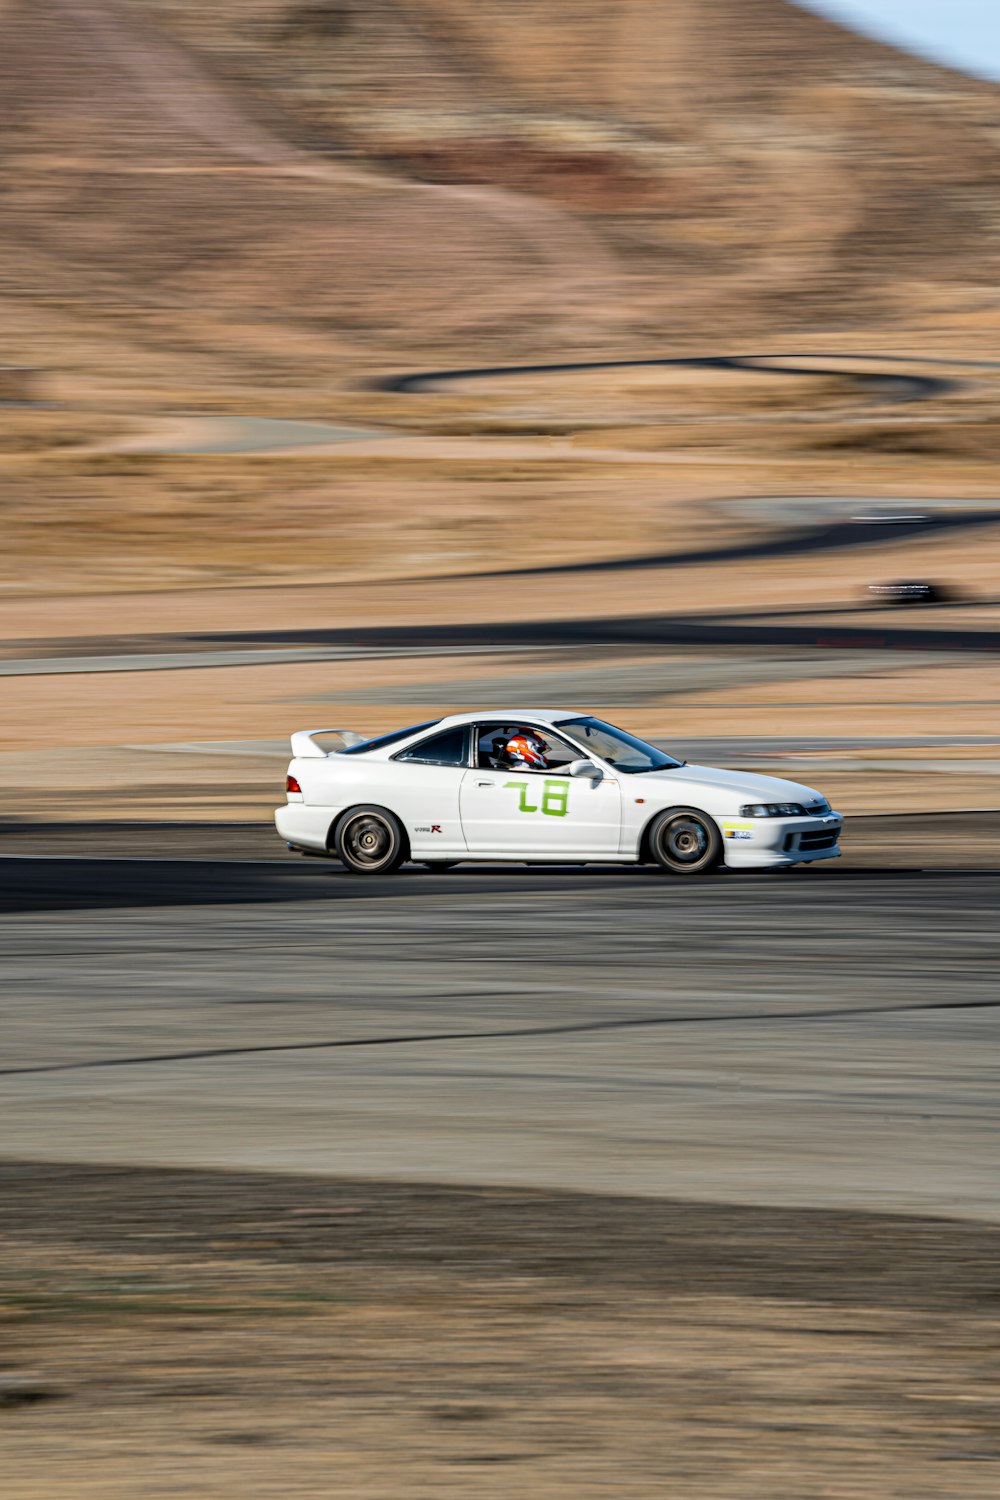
[0,1163,1000,1500]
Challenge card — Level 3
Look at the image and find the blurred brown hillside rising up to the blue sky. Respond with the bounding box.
[0,0,1000,369]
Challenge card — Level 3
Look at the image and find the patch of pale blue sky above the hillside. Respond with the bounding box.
[798,0,1000,80]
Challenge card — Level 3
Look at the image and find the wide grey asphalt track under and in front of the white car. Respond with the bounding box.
[0,815,1000,1220]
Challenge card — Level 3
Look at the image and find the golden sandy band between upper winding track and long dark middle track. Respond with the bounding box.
[0,462,997,615]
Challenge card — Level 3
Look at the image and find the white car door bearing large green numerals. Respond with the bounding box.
[460,728,621,860]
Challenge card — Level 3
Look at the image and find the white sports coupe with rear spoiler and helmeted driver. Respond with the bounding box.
[274,708,843,875]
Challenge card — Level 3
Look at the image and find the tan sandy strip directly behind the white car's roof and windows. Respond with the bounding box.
[0,650,1000,822]
